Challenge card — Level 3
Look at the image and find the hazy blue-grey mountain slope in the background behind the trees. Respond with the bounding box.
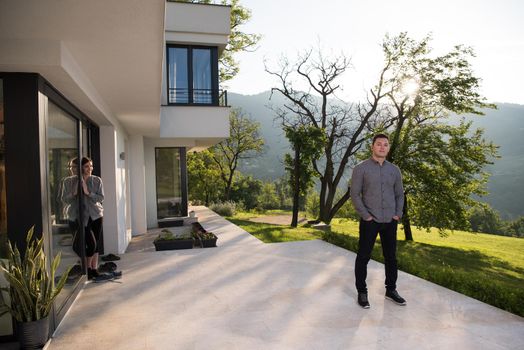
[228,91,524,219]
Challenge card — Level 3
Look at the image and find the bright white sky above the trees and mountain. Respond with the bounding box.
[225,0,524,104]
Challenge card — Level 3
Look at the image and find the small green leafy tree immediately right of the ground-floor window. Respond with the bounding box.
[187,150,222,206]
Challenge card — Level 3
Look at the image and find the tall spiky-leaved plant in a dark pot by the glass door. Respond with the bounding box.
[0,226,71,349]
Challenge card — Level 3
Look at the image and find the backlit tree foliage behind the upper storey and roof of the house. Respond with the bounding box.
[182,0,261,82]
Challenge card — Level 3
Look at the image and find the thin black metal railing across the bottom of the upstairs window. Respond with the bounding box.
[167,88,227,107]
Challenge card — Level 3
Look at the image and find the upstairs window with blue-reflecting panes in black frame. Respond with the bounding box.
[167,45,218,105]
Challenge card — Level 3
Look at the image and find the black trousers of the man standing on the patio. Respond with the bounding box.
[355,219,398,293]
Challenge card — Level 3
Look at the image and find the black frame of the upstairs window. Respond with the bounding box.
[166,44,219,106]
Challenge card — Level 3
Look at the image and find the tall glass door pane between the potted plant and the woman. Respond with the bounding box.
[47,100,83,309]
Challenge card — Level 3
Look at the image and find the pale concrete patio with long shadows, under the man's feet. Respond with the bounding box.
[47,207,524,350]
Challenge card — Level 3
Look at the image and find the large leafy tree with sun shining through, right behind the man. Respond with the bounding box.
[371,33,497,240]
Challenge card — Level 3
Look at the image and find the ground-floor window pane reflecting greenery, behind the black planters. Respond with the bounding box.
[155,147,187,219]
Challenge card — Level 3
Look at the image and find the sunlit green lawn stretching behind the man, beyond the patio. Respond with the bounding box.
[229,213,524,316]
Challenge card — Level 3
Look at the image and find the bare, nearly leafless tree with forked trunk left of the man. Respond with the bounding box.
[266,49,389,223]
